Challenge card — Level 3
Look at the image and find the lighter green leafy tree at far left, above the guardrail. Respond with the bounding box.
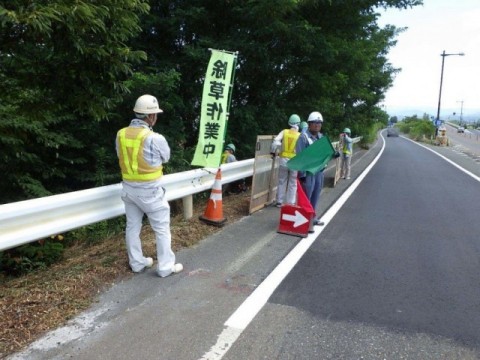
[0,0,149,203]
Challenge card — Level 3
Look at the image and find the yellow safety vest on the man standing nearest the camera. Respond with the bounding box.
[117,127,163,181]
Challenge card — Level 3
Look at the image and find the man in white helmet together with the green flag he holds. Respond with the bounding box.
[287,111,336,226]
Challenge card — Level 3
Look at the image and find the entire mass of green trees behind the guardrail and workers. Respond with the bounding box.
[0,0,422,202]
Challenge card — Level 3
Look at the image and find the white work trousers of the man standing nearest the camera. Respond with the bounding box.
[122,188,175,277]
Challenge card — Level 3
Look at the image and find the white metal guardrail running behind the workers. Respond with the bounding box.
[0,138,361,251]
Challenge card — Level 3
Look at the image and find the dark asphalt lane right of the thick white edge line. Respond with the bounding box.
[225,133,480,359]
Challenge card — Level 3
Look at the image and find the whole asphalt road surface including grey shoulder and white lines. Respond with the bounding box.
[12,131,480,360]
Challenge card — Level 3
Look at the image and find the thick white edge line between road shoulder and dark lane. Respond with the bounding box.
[199,136,385,360]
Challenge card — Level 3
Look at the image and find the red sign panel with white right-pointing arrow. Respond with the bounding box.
[277,205,315,237]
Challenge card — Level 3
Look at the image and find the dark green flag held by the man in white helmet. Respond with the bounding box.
[287,136,335,175]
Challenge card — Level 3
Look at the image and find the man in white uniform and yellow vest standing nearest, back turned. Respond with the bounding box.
[116,95,183,277]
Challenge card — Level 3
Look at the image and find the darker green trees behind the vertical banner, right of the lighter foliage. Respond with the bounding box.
[132,0,421,158]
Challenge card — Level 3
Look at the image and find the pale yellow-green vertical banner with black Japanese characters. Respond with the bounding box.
[192,50,237,167]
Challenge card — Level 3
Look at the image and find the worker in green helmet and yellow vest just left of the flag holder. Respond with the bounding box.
[270,114,300,207]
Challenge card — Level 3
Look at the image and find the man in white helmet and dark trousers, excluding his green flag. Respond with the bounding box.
[295,111,324,226]
